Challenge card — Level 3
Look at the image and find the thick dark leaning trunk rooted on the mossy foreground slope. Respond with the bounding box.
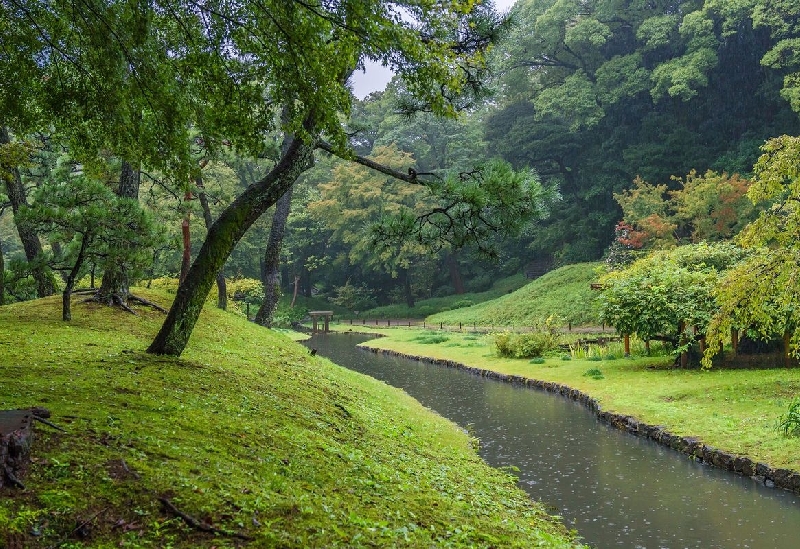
[147,134,315,356]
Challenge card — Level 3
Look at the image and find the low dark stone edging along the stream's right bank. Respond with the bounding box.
[357,342,800,494]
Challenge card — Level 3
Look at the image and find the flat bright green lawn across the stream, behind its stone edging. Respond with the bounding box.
[360,328,800,470]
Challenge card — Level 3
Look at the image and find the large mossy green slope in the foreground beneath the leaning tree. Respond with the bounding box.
[0,293,588,549]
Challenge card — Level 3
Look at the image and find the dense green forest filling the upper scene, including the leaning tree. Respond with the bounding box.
[0,0,800,352]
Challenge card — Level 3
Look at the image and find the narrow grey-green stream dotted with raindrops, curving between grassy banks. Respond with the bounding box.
[308,335,800,549]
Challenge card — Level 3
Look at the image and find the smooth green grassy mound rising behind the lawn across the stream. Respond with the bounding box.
[428,263,600,326]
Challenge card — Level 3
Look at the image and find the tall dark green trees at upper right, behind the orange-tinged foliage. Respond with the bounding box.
[486,0,800,262]
